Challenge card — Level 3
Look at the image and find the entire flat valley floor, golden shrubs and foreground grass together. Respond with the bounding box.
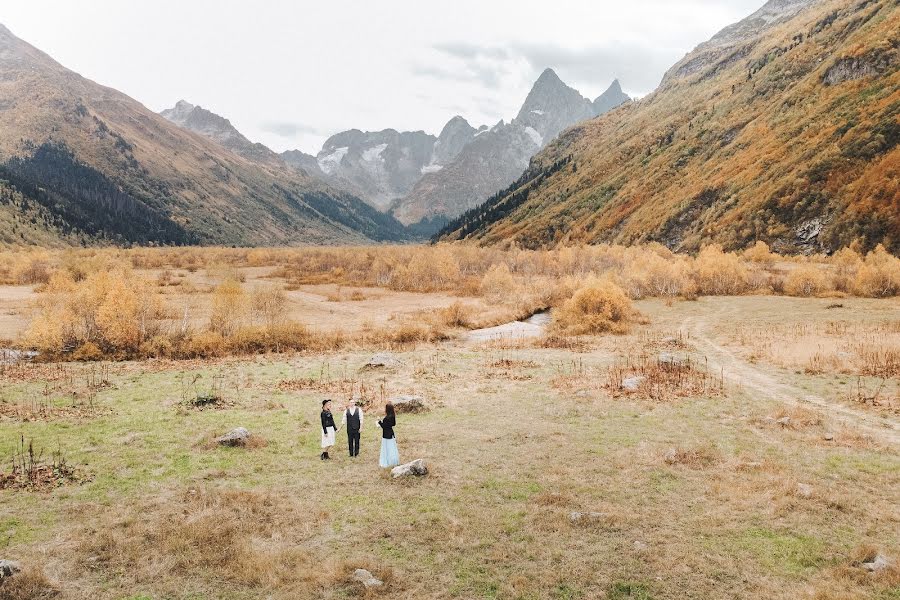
[0,241,900,600]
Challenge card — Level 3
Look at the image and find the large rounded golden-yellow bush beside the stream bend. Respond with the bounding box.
[553,280,635,335]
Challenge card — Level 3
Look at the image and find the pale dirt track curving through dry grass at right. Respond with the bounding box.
[682,306,900,446]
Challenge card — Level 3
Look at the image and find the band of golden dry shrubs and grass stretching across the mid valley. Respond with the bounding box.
[0,244,900,360]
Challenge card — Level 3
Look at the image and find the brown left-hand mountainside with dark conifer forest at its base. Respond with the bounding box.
[0,26,407,245]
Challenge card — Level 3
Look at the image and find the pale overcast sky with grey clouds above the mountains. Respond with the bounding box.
[0,0,764,154]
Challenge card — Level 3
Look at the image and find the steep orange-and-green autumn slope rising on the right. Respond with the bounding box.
[438,0,900,252]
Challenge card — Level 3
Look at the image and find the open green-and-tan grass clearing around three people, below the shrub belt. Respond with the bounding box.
[0,295,900,600]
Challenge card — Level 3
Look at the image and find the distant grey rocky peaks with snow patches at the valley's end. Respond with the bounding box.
[160,69,630,234]
